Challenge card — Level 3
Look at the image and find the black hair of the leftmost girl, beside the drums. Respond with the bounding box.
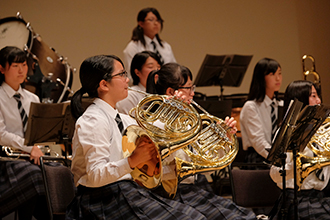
[0,46,27,85]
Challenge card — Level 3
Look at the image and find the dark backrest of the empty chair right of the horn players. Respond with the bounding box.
[230,167,281,208]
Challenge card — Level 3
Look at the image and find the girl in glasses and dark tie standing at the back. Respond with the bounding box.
[124,8,176,81]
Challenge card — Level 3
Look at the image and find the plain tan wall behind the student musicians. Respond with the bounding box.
[0,0,330,104]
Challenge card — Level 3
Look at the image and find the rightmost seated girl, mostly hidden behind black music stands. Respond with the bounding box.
[270,80,330,220]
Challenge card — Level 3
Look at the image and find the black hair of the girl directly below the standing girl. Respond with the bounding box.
[131,51,161,85]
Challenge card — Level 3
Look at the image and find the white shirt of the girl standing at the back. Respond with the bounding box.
[124,35,176,79]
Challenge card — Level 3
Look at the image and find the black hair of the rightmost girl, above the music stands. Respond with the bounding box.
[283,80,319,112]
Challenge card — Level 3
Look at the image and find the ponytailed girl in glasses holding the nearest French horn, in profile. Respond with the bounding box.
[66,55,206,219]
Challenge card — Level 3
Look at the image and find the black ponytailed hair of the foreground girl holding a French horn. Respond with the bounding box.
[71,55,124,119]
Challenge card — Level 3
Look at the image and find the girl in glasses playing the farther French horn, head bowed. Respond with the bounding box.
[147,63,256,219]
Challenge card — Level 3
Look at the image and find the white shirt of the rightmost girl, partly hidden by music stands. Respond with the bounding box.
[270,147,330,190]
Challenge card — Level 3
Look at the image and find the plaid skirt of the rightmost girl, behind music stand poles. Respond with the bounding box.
[272,189,330,220]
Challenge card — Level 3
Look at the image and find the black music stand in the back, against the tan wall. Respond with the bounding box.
[194,54,252,100]
